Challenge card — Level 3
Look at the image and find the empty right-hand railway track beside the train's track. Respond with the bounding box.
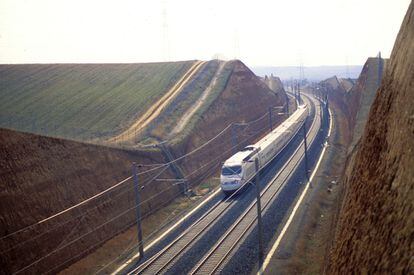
[189,96,320,274]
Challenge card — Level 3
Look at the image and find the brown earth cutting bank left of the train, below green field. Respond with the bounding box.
[0,61,285,274]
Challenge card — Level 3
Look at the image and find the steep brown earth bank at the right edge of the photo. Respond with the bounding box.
[327,3,414,274]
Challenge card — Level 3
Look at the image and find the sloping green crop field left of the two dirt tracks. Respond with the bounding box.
[0,61,194,140]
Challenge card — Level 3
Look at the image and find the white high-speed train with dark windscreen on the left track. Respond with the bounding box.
[220,105,308,194]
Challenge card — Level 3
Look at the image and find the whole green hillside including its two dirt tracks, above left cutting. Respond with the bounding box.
[0,60,266,147]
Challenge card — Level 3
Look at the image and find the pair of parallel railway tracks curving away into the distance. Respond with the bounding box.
[128,94,321,274]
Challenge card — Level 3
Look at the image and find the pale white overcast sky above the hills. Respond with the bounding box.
[0,0,410,66]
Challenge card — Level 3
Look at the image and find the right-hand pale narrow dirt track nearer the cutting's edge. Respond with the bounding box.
[168,61,227,138]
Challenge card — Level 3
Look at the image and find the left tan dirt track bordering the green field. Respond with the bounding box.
[108,61,206,142]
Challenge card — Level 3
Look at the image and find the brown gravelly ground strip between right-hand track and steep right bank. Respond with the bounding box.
[265,104,347,274]
